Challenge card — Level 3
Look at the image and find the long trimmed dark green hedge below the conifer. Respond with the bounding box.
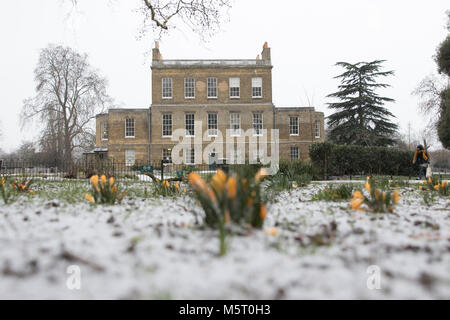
[309,142,419,178]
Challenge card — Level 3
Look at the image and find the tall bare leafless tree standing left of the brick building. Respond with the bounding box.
[21,45,111,164]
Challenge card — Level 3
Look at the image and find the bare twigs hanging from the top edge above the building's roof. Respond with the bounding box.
[70,0,231,38]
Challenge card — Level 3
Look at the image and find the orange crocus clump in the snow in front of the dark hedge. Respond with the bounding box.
[350,178,401,213]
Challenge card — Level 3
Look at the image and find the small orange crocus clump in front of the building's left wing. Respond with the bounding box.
[85,175,125,204]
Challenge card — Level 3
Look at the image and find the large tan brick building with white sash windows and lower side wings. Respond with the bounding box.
[95,43,324,165]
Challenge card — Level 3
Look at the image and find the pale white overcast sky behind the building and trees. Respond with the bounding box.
[0,0,450,151]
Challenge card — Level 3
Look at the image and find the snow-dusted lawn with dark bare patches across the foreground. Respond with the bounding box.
[0,182,450,299]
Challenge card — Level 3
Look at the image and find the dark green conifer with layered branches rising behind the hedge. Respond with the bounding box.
[327,60,398,146]
